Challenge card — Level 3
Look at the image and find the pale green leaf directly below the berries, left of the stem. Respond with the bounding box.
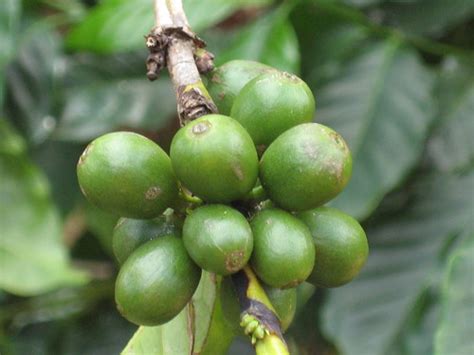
[122,272,231,355]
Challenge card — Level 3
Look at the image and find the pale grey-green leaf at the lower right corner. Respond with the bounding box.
[435,234,474,355]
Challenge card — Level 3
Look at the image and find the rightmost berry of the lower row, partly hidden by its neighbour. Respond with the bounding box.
[298,207,369,287]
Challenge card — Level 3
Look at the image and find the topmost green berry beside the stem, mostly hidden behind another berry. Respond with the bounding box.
[207,60,276,115]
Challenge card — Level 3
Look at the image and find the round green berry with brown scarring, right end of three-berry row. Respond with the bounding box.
[260,123,352,211]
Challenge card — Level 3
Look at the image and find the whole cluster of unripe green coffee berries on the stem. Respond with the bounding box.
[77,61,368,327]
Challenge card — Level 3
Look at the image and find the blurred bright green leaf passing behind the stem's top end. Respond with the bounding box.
[67,0,272,53]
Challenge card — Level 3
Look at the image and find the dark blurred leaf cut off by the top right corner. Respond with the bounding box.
[384,0,474,35]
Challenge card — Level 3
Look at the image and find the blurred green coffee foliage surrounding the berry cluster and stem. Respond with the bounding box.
[0,0,474,355]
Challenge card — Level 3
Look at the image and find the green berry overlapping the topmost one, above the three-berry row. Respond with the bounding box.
[230,71,315,146]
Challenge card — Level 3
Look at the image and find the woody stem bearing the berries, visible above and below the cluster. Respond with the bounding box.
[146,0,289,355]
